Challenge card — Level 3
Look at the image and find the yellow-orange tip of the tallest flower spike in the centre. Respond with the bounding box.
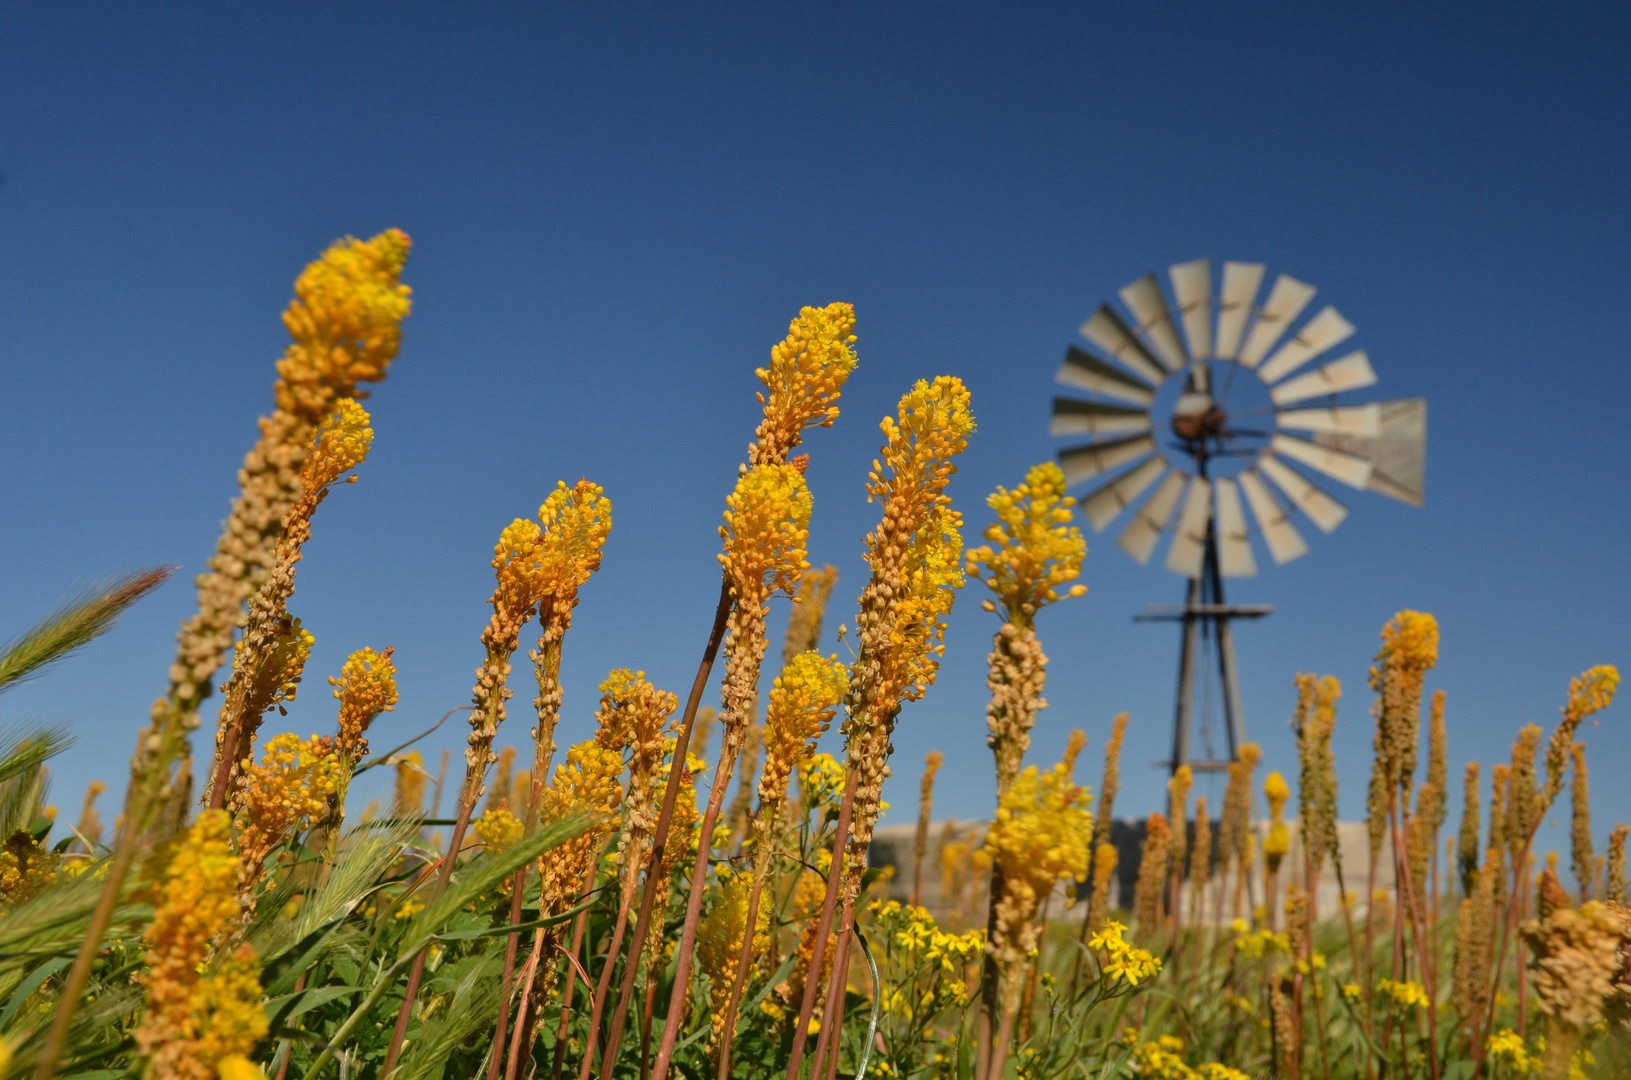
[749,303,855,465]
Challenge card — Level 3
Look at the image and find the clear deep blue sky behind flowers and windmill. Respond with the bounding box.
[0,2,1631,861]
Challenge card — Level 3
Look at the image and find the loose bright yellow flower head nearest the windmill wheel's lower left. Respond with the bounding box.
[967,462,1088,625]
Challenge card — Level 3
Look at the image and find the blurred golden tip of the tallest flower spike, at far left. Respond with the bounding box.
[276,228,411,419]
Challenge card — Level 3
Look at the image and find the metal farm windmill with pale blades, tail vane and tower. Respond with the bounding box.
[1050,259,1427,772]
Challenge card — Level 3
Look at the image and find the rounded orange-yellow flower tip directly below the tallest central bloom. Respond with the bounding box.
[719,465,811,604]
